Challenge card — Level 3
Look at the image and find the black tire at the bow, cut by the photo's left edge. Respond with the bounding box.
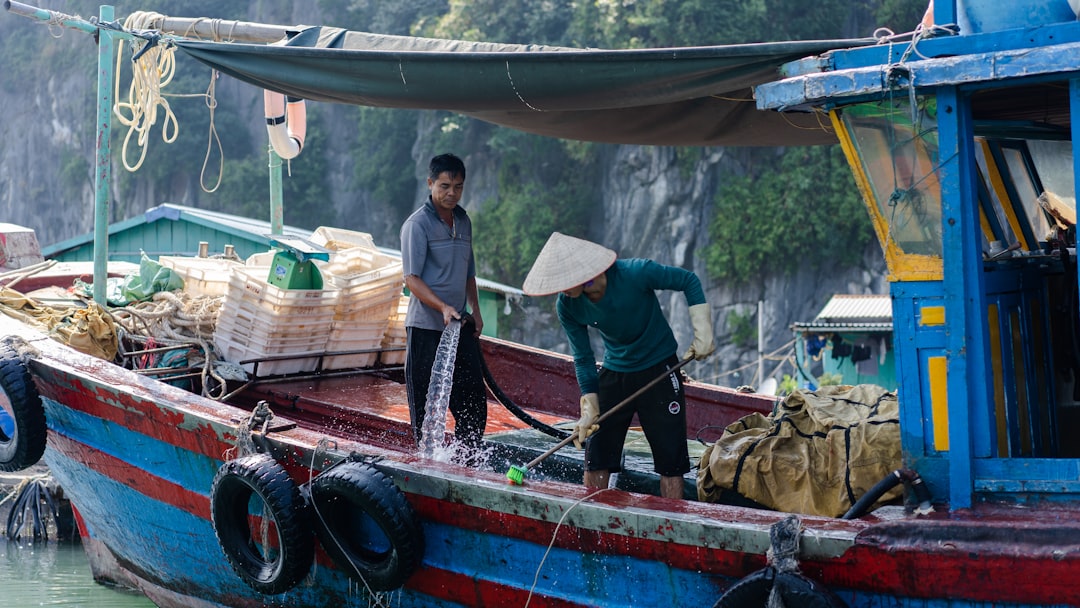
[0,342,49,472]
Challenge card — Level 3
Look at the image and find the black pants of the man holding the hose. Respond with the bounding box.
[405,323,487,448]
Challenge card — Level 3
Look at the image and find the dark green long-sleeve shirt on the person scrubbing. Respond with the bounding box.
[555,259,705,394]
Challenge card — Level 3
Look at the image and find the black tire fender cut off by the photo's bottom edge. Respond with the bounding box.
[713,566,848,608]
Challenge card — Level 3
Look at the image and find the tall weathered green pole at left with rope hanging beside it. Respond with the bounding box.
[94,4,114,307]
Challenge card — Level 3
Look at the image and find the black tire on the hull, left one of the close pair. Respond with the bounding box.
[211,454,315,595]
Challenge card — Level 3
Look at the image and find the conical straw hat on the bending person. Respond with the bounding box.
[522,232,616,296]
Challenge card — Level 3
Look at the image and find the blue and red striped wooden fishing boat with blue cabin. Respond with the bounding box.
[0,0,1080,608]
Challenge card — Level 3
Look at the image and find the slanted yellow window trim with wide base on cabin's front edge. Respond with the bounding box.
[828,109,945,282]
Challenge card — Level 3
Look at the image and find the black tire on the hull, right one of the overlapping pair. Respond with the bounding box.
[311,461,424,591]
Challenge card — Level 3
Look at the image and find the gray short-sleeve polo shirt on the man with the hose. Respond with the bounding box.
[402,198,476,332]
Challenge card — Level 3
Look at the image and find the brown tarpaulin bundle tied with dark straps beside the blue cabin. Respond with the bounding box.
[698,384,903,517]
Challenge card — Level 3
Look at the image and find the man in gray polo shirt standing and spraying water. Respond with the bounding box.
[401,154,487,461]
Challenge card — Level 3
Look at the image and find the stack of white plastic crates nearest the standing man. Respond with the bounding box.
[323,246,404,369]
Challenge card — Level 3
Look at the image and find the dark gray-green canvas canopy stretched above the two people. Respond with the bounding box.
[176,27,869,146]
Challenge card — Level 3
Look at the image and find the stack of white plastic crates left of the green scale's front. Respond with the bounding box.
[214,265,339,376]
